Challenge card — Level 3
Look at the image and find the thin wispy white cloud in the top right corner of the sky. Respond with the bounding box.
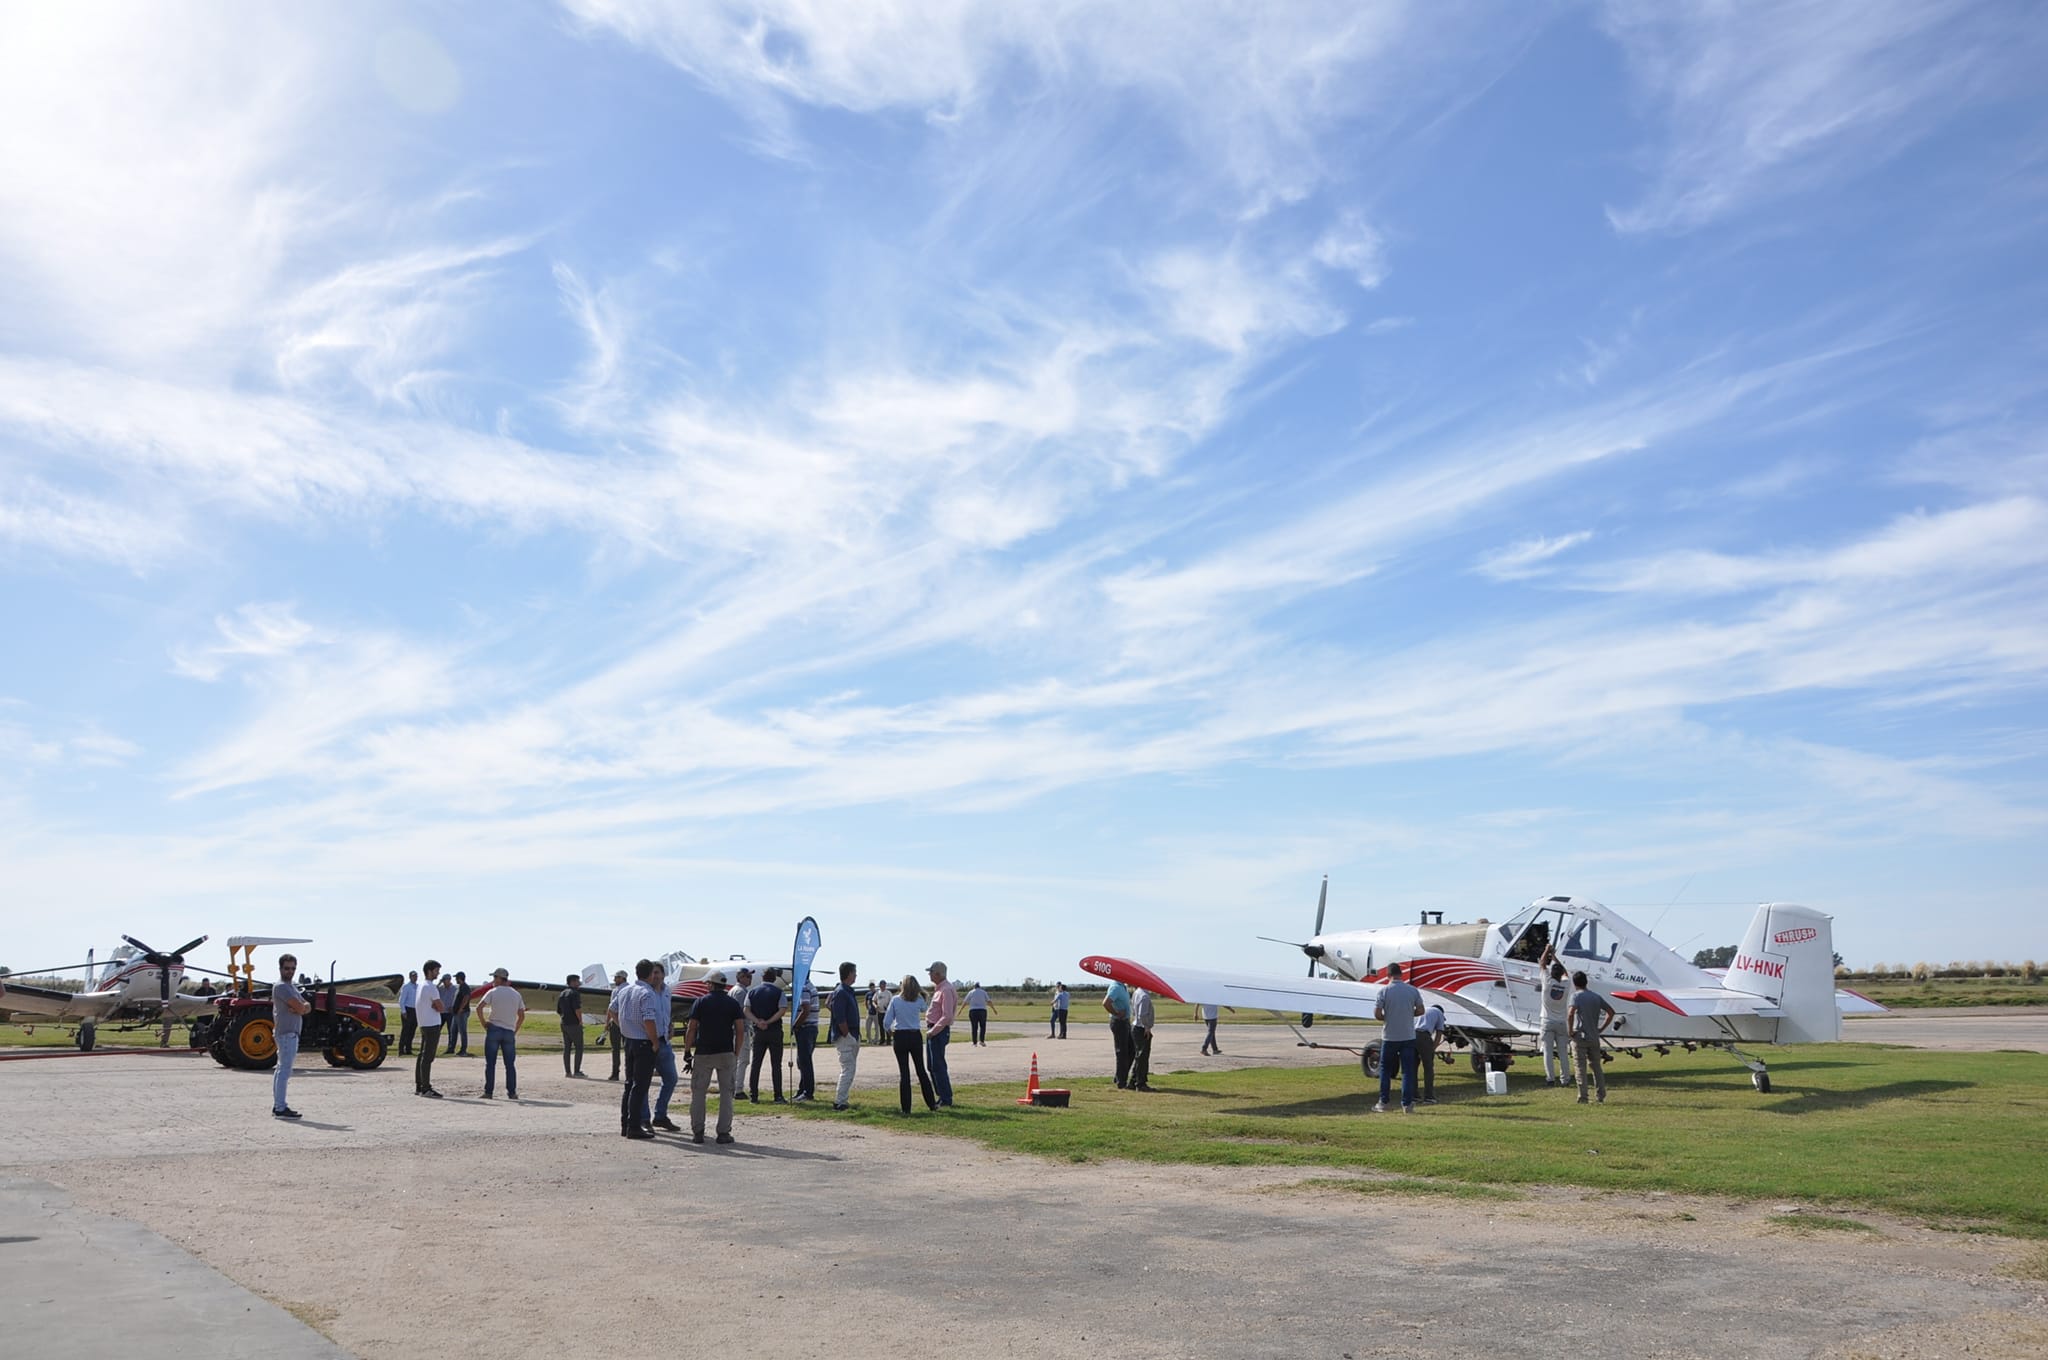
[1604,0,2042,231]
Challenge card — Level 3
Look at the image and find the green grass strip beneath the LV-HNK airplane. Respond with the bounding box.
[786,1045,2048,1237]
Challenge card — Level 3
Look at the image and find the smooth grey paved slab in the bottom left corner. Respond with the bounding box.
[0,1176,348,1360]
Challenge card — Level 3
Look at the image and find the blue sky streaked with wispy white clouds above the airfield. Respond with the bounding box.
[0,0,2048,979]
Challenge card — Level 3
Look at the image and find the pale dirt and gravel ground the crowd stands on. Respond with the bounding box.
[0,1026,2048,1360]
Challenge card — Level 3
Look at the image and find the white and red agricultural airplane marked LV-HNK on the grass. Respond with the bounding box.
[1081,879,1884,1092]
